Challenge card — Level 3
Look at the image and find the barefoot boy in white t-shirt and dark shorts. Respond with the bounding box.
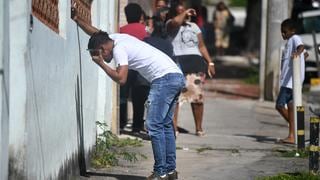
[276,19,305,144]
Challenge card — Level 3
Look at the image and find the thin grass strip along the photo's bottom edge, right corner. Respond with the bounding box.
[256,172,320,180]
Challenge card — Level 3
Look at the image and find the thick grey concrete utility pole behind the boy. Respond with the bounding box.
[264,0,291,101]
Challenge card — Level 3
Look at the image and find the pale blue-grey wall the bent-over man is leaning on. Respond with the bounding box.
[9,0,117,180]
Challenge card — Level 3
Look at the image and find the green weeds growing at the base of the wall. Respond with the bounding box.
[91,122,146,168]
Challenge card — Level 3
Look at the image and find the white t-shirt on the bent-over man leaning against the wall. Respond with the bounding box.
[110,33,182,82]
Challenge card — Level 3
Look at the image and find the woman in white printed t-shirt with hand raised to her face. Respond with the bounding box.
[167,4,215,136]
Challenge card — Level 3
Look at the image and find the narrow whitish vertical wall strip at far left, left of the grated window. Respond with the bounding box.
[9,0,29,179]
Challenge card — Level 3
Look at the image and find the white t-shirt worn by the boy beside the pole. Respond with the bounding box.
[280,35,305,89]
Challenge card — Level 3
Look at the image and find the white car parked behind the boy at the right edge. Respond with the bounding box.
[297,9,320,83]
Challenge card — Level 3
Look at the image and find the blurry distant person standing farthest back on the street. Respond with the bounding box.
[213,1,234,56]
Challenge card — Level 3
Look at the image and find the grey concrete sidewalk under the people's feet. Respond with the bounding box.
[83,89,308,180]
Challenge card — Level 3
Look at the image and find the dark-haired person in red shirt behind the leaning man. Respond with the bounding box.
[120,3,149,133]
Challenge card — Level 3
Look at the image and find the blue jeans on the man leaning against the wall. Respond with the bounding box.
[146,73,185,176]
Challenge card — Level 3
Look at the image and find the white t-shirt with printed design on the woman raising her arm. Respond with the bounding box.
[172,22,201,56]
